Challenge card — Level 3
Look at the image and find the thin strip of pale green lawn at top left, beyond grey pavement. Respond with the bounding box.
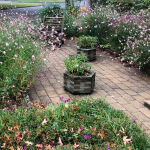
[0,2,42,10]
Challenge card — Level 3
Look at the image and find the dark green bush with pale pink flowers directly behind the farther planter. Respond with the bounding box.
[81,8,110,44]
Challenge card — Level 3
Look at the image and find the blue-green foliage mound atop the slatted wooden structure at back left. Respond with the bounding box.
[39,4,63,21]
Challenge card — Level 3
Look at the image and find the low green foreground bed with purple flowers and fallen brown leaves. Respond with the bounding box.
[0,98,150,150]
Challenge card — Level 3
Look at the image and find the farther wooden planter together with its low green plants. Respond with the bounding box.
[76,36,98,61]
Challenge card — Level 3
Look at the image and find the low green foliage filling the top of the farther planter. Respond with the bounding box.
[76,35,98,48]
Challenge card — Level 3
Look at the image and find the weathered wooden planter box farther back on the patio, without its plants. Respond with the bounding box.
[77,46,96,61]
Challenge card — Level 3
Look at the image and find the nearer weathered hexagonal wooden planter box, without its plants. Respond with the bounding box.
[64,71,95,94]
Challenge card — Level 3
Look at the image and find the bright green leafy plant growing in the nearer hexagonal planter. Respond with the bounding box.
[64,54,91,76]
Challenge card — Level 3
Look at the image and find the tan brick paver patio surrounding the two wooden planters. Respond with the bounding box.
[29,41,150,134]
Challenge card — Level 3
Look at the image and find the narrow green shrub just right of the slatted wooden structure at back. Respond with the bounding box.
[64,10,78,37]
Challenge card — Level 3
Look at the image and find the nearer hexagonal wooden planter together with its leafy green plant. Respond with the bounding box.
[64,53,95,94]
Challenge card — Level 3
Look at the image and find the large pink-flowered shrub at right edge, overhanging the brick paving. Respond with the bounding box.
[109,11,150,68]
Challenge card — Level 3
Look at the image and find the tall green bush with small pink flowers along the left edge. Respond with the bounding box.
[0,18,40,100]
